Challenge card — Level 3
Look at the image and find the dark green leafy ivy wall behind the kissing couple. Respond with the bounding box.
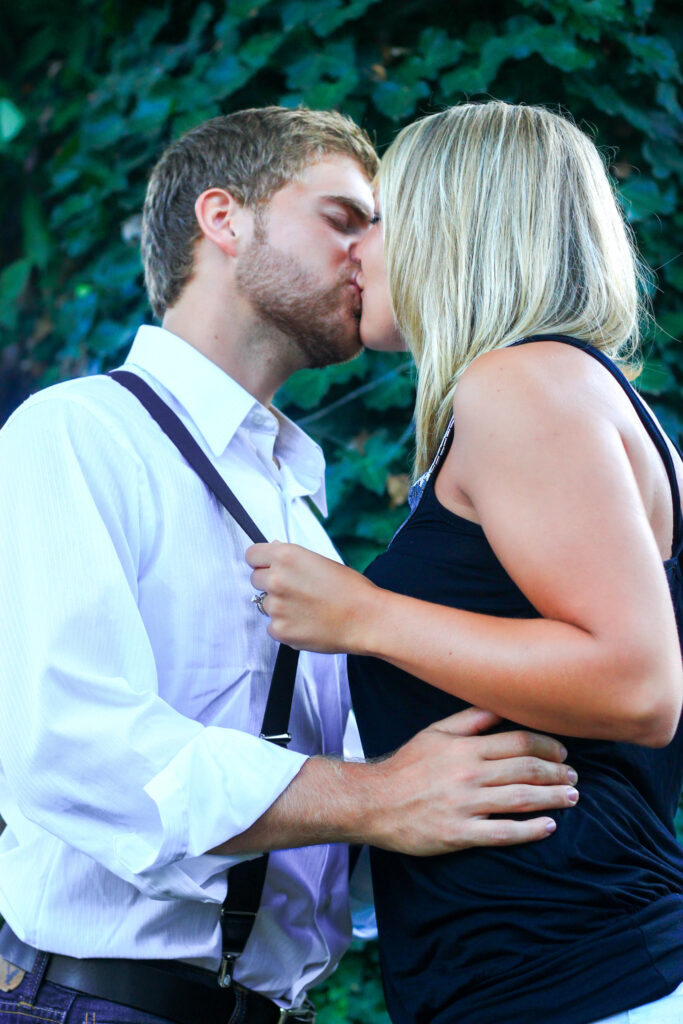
[0,0,683,1024]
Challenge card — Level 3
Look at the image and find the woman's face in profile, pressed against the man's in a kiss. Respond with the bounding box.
[351,196,405,352]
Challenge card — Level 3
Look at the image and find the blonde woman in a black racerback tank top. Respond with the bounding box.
[248,101,683,1024]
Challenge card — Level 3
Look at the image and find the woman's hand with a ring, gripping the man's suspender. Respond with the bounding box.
[247,541,383,653]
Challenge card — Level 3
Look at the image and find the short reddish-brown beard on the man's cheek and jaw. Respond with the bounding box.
[237,229,361,368]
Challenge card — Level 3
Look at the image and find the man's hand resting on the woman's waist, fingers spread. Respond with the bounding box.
[362,708,579,856]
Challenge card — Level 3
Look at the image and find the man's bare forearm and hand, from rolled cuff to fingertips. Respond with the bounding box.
[212,708,579,856]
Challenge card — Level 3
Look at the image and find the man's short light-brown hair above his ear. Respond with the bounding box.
[142,106,379,318]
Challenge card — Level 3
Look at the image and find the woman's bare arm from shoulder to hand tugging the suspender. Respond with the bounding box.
[249,345,683,746]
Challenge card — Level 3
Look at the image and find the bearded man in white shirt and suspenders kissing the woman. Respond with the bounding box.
[0,108,575,1024]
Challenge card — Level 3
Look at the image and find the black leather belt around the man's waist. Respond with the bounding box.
[44,953,315,1024]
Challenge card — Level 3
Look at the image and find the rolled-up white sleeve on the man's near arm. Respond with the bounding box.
[0,396,306,902]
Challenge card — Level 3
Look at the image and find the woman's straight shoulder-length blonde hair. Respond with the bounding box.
[379,100,643,475]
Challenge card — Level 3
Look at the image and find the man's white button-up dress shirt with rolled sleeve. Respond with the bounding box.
[0,327,350,1004]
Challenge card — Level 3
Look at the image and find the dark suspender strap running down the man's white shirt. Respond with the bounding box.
[109,370,299,988]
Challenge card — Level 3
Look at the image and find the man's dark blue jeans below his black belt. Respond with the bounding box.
[0,953,194,1024]
